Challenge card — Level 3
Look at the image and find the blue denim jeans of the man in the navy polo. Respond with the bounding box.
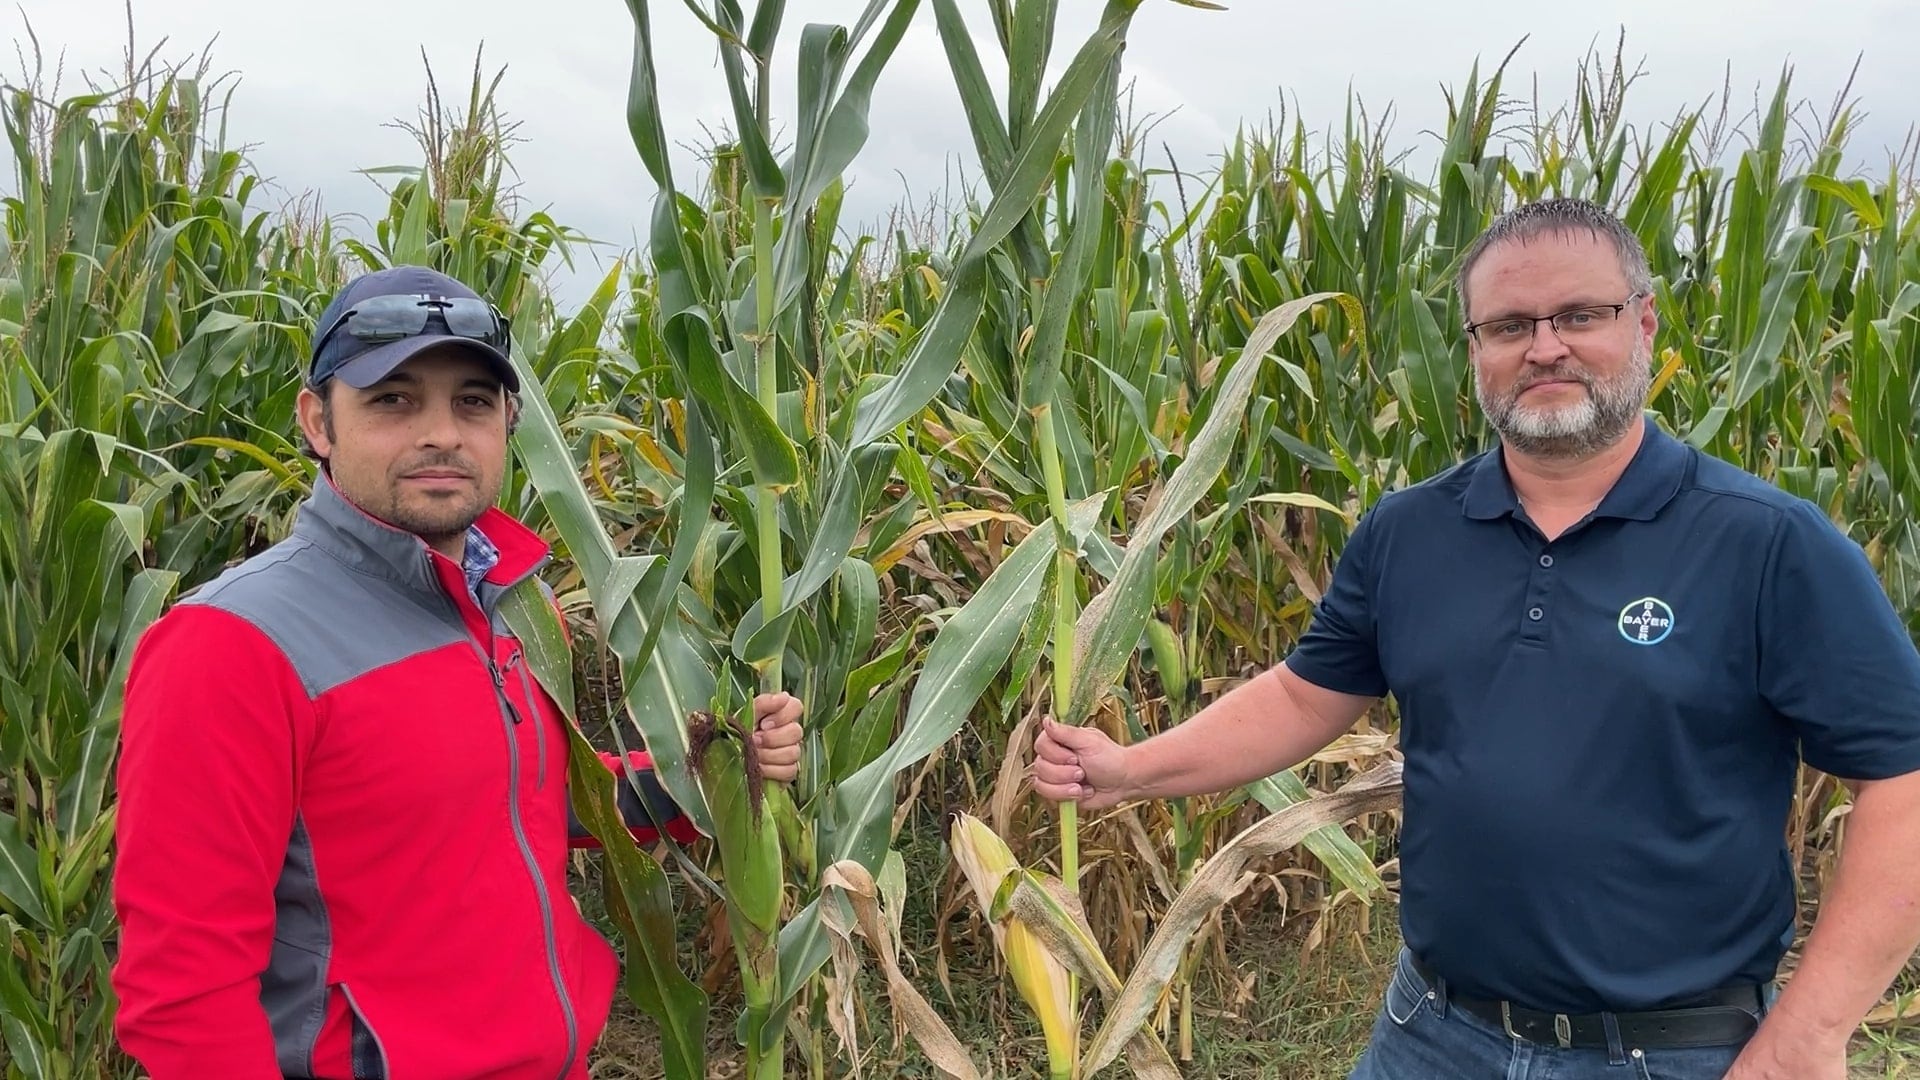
[1348,949,1759,1080]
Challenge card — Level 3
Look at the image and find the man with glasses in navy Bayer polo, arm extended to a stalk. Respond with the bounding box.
[1033,200,1920,1080]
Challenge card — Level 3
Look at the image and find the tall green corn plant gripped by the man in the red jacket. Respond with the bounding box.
[495,0,1221,1076]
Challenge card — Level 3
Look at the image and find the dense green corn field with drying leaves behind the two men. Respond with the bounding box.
[0,0,1920,1080]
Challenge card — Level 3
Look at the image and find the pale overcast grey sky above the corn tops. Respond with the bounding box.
[0,0,1920,305]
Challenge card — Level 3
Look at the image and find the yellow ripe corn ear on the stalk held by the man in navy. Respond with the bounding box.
[950,813,1081,1080]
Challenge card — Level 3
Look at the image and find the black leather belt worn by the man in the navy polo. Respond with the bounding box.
[1413,957,1763,1049]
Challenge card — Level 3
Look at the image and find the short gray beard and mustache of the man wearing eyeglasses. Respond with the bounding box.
[1475,346,1653,459]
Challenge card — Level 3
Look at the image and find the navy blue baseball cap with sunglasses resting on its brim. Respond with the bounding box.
[307,265,520,392]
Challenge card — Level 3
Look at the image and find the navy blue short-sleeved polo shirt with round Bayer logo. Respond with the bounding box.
[1286,423,1920,1013]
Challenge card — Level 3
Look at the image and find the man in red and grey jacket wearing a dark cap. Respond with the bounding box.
[113,267,801,1080]
